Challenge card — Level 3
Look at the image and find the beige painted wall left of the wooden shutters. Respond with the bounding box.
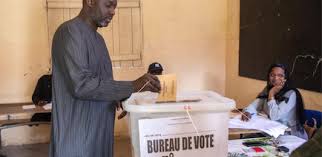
[0,0,49,103]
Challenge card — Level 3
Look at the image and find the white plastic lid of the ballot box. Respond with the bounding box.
[123,91,236,113]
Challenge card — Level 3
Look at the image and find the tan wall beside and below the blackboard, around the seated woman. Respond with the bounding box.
[226,0,322,111]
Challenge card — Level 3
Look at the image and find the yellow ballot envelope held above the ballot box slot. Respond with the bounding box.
[157,74,177,102]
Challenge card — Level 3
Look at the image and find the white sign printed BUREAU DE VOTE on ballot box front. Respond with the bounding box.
[139,113,228,157]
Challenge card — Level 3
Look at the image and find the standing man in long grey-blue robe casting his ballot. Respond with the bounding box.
[49,0,160,157]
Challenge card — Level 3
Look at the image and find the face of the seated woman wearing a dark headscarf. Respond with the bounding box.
[269,67,286,86]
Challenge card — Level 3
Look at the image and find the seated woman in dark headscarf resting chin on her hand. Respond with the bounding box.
[242,64,307,139]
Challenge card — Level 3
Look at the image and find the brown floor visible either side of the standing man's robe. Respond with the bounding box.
[0,138,131,157]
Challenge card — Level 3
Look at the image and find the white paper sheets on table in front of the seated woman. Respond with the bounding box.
[229,116,288,138]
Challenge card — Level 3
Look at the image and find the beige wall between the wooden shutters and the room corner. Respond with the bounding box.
[142,0,227,94]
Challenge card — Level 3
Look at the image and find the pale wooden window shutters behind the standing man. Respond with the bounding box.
[47,0,142,68]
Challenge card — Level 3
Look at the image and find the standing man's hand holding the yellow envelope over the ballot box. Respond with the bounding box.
[133,74,161,92]
